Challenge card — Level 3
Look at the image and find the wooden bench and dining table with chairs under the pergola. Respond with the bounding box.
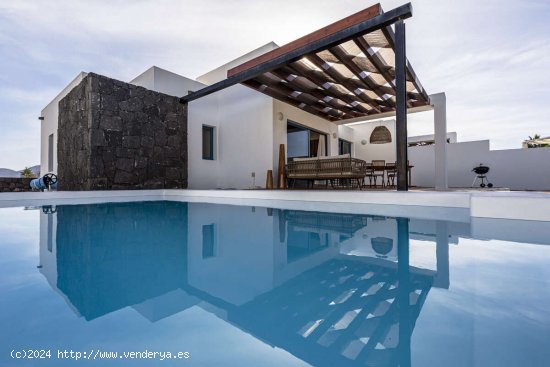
[285,154,412,189]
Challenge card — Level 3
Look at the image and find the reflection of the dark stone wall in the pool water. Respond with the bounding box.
[56,202,188,320]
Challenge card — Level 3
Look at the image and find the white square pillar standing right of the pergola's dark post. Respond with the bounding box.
[430,93,449,190]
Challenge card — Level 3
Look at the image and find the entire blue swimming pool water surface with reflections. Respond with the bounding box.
[0,201,550,367]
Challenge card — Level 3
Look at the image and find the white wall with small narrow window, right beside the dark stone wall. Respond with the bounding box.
[187,85,273,189]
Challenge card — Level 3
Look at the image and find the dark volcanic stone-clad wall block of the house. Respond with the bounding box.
[57,73,187,191]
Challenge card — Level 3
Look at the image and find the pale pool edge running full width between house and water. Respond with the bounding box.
[0,189,550,221]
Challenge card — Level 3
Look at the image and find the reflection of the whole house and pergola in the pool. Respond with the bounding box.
[40,202,452,366]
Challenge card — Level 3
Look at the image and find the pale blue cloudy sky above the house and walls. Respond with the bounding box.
[0,0,550,169]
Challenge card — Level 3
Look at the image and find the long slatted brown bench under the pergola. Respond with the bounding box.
[286,154,367,189]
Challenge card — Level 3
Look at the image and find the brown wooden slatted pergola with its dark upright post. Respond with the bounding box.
[180,3,430,190]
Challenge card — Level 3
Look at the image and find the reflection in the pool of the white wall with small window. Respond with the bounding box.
[187,203,279,305]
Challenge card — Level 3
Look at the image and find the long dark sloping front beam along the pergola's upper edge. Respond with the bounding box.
[180,3,412,103]
